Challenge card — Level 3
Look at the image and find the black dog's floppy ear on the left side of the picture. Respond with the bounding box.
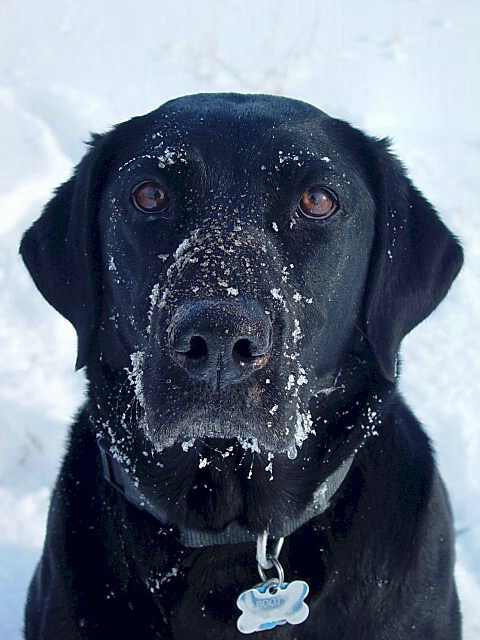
[20,136,108,369]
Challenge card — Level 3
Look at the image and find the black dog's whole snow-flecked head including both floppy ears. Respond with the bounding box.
[22,95,461,532]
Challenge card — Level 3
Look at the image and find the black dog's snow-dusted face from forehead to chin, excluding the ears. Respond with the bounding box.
[96,92,374,457]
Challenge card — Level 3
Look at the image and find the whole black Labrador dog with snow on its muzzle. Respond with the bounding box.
[21,95,462,640]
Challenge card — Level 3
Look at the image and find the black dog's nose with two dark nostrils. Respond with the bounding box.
[167,300,272,389]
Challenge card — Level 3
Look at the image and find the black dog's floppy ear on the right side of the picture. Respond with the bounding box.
[363,139,463,381]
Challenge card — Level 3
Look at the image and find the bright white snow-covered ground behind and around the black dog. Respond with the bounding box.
[0,0,480,640]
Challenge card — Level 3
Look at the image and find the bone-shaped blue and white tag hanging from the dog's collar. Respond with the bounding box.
[237,578,309,633]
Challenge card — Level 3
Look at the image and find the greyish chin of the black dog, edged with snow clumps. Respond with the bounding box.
[141,405,314,459]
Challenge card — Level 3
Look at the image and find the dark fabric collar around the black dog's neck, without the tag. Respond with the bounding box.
[98,438,355,547]
